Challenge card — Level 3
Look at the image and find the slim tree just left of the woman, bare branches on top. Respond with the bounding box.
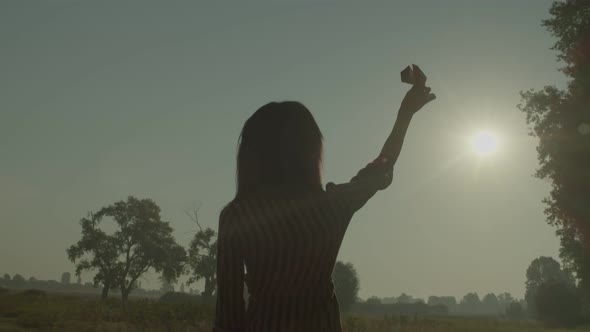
[186,209,217,296]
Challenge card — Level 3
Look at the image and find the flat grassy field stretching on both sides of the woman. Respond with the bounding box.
[0,291,590,332]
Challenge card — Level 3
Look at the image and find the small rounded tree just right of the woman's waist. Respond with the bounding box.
[332,261,359,310]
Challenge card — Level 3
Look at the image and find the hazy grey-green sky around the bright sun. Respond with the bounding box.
[0,0,564,297]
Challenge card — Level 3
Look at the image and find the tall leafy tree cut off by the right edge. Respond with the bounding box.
[518,0,590,314]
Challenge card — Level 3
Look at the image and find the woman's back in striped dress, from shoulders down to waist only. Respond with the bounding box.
[236,193,350,297]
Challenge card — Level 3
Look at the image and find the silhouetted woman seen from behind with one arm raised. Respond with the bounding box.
[213,71,435,332]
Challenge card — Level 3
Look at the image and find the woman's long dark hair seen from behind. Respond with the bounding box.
[234,101,323,200]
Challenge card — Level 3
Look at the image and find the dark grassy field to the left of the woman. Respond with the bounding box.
[0,293,214,332]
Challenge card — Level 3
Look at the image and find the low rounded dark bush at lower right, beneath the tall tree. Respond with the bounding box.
[535,279,581,327]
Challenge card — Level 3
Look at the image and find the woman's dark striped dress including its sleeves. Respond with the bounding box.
[213,159,393,332]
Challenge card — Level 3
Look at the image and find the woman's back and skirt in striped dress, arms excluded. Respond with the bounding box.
[235,193,350,331]
